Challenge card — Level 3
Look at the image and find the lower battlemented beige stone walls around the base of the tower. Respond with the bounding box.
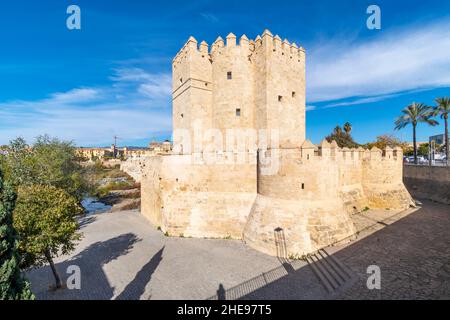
[141,141,412,255]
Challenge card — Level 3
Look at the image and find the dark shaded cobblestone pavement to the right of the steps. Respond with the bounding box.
[331,201,450,300]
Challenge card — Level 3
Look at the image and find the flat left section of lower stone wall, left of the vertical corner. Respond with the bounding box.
[141,155,256,239]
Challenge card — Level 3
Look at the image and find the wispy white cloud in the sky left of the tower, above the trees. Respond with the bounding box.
[0,69,172,145]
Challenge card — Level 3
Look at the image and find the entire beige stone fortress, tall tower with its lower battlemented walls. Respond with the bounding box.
[141,30,412,255]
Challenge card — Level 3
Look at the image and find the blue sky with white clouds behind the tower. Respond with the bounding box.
[0,0,450,146]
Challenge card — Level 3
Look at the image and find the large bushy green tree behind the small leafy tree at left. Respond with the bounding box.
[5,135,87,201]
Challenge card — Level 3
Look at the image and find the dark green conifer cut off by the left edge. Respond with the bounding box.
[0,171,34,300]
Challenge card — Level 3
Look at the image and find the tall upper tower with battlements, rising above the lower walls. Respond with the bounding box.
[172,30,306,153]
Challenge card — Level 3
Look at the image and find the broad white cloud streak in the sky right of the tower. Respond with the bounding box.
[307,21,450,105]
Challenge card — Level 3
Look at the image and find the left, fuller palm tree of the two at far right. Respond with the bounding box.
[395,102,439,164]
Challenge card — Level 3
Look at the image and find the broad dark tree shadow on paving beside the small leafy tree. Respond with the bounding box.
[27,233,140,300]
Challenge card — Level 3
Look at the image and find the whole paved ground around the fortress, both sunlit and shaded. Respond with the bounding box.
[27,202,450,299]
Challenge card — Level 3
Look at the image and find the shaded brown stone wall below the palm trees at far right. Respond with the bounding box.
[403,165,450,204]
